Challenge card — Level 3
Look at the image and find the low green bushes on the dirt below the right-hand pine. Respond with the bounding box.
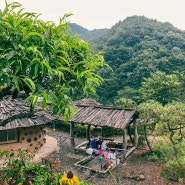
[143,138,185,179]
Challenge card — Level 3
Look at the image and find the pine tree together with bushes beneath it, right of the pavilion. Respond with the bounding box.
[138,101,185,178]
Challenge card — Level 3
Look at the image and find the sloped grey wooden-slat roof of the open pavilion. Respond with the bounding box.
[66,99,136,129]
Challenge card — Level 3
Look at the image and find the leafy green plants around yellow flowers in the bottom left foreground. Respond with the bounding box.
[0,149,93,185]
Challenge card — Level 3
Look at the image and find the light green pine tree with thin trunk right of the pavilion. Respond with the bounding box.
[138,101,185,157]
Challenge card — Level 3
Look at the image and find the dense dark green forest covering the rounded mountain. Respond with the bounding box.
[69,16,185,105]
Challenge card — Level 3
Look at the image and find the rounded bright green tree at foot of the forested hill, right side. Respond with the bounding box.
[140,71,182,105]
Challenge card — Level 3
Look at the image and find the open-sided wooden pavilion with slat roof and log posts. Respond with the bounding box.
[62,98,138,161]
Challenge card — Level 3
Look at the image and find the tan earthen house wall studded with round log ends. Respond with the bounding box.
[0,125,46,152]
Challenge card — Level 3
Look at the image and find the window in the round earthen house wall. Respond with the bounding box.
[0,129,17,144]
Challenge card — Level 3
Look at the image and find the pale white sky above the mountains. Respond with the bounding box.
[0,0,185,30]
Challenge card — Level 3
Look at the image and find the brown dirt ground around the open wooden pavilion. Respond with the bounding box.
[45,130,179,185]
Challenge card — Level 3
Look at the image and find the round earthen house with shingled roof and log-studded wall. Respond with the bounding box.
[0,96,54,151]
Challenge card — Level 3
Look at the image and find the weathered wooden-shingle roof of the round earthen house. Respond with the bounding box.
[0,96,54,130]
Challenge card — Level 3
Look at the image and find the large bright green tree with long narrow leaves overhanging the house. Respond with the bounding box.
[0,2,104,118]
